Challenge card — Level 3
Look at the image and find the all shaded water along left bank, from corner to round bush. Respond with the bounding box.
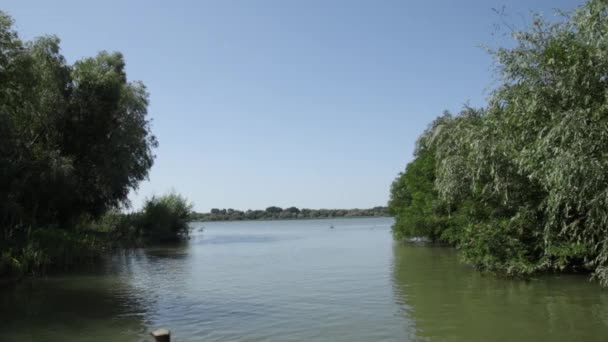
[0,244,195,342]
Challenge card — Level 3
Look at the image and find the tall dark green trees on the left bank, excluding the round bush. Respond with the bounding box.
[0,11,157,273]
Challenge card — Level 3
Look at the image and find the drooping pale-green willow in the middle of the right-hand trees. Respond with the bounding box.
[432,108,542,275]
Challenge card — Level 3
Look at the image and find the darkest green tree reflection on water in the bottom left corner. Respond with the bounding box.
[0,275,145,341]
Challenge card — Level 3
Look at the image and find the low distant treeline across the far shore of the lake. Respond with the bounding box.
[191,206,388,221]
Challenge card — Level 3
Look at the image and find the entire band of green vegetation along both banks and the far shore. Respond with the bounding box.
[0,0,608,286]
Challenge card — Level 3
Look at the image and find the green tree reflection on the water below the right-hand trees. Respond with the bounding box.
[393,243,608,341]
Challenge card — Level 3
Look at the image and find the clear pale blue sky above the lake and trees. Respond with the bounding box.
[0,0,582,211]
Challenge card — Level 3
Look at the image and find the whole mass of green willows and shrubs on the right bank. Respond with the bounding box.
[389,0,608,286]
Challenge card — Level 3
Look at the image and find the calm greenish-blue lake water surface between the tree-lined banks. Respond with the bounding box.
[0,218,608,342]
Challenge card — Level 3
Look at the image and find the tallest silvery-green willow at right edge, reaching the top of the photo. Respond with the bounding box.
[491,0,608,284]
